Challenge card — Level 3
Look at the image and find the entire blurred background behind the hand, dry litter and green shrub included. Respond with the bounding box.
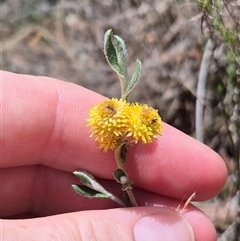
[0,0,240,241]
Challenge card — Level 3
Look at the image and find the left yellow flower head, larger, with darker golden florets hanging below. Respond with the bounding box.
[87,98,129,151]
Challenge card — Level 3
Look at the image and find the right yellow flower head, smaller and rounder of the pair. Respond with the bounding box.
[125,103,162,144]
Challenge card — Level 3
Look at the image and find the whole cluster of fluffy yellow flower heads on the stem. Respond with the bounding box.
[87,98,162,151]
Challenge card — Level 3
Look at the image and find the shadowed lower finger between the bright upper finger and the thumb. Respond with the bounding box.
[0,165,218,218]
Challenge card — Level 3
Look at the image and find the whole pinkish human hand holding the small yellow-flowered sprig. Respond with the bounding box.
[0,72,226,241]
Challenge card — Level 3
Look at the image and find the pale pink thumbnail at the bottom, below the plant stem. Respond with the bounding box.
[134,208,195,241]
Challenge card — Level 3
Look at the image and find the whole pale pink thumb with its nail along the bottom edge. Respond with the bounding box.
[2,207,199,241]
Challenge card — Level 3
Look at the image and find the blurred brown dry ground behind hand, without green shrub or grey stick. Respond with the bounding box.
[1,0,239,238]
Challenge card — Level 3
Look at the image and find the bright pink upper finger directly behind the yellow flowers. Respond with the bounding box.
[2,72,226,200]
